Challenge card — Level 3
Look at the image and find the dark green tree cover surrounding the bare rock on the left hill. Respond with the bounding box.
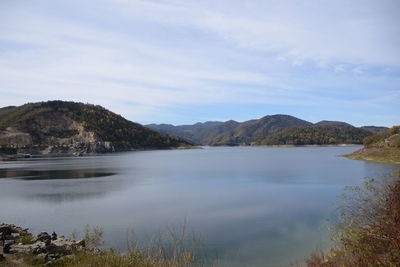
[0,101,190,152]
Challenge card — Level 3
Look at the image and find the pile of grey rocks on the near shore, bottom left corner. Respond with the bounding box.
[0,224,87,266]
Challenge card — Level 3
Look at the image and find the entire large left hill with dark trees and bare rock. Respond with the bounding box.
[0,101,190,157]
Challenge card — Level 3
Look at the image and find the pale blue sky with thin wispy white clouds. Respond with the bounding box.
[0,0,400,126]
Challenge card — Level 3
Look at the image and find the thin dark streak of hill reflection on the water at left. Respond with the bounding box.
[0,169,116,180]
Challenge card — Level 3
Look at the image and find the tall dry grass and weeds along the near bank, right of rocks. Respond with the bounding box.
[55,222,205,267]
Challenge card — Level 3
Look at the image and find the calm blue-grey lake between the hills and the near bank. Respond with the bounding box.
[0,146,399,266]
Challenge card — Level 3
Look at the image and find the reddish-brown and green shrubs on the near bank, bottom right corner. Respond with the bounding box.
[307,173,400,267]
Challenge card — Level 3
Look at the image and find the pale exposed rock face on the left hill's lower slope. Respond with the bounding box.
[0,113,114,155]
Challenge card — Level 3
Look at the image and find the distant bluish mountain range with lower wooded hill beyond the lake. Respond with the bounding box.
[146,114,387,146]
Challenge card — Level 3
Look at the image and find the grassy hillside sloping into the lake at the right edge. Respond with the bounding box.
[343,126,400,163]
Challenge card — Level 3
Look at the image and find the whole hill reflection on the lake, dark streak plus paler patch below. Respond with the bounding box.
[0,168,133,204]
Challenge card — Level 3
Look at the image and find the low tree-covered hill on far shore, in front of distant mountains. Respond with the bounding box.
[257,126,371,146]
